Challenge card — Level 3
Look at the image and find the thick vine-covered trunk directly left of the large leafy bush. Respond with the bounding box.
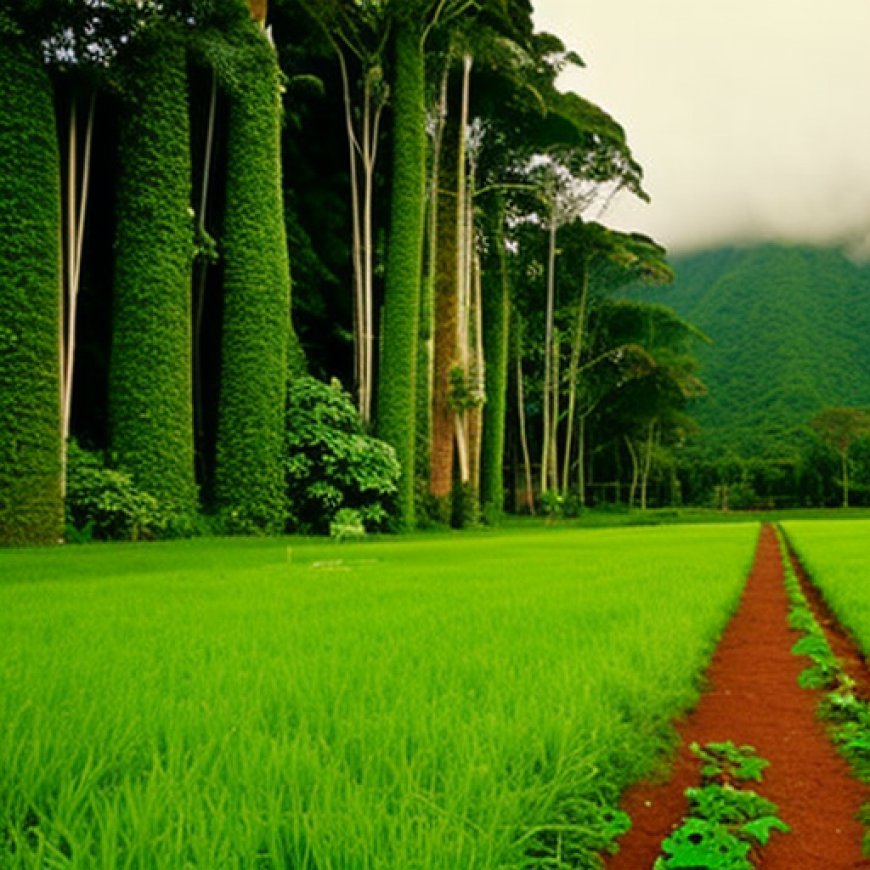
[215,28,298,533]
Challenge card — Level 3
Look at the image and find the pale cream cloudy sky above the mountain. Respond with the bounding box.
[532,0,870,253]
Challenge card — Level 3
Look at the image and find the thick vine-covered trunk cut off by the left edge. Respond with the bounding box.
[0,35,63,544]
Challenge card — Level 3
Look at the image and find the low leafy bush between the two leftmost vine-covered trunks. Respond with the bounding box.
[66,441,167,541]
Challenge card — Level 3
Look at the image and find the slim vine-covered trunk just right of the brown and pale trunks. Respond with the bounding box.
[480,197,510,514]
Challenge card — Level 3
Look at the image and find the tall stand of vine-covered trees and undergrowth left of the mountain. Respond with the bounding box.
[0,0,864,543]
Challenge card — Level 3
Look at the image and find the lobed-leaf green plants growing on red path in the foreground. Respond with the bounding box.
[654,740,789,870]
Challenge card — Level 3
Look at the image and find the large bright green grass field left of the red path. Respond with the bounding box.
[0,524,757,870]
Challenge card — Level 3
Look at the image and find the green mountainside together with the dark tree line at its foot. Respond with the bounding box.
[628,244,870,506]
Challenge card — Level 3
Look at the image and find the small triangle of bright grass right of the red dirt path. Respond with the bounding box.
[782,520,870,654]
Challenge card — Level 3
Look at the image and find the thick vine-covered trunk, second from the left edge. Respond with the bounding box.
[109,27,197,518]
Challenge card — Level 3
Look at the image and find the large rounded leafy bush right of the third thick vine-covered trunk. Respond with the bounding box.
[284,377,399,534]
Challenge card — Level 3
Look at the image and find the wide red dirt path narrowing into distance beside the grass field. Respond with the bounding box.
[607,526,870,870]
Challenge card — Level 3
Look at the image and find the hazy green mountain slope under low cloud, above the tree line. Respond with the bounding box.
[632,244,870,457]
